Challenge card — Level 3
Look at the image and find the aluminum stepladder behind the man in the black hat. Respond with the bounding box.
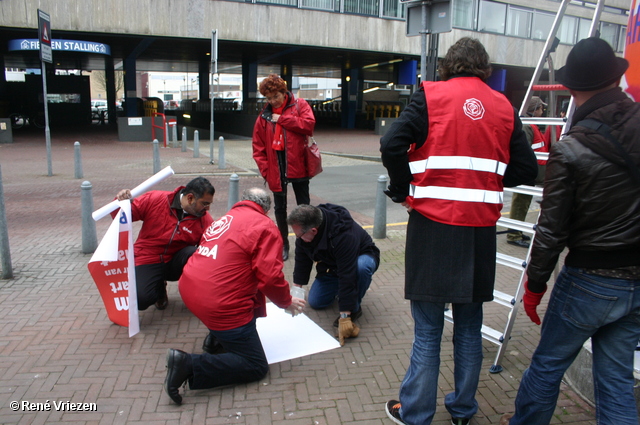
[445,0,604,373]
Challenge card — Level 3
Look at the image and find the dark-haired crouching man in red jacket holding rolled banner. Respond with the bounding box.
[112,177,215,310]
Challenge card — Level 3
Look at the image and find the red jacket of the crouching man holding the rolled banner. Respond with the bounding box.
[112,186,213,266]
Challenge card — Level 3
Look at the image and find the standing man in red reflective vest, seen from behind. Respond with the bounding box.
[380,37,538,425]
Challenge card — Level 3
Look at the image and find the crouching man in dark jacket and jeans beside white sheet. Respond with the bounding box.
[287,204,380,345]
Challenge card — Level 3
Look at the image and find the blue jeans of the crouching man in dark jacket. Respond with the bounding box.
[307,254,377,311]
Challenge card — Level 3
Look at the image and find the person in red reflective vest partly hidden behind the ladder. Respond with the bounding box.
[507,96,549,248]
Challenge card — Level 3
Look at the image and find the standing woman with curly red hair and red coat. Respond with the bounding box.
[253,74,316,261]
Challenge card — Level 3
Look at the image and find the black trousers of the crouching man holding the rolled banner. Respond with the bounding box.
[136,246,196,310]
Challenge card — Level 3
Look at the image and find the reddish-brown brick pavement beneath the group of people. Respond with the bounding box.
[0,127,595,425]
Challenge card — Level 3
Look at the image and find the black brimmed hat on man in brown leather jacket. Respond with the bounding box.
[556,37,629,91]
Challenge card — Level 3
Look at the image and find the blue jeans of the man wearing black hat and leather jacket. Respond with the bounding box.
[509,267,640,425]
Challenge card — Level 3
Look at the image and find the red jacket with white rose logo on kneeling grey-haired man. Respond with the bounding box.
[178,201,291,331]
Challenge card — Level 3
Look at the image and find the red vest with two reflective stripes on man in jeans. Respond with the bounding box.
[407,77,514,227]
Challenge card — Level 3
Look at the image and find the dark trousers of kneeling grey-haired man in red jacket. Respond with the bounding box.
[189,319,269,390]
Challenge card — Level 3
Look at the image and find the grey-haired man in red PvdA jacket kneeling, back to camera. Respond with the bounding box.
[164,188,305,404]
